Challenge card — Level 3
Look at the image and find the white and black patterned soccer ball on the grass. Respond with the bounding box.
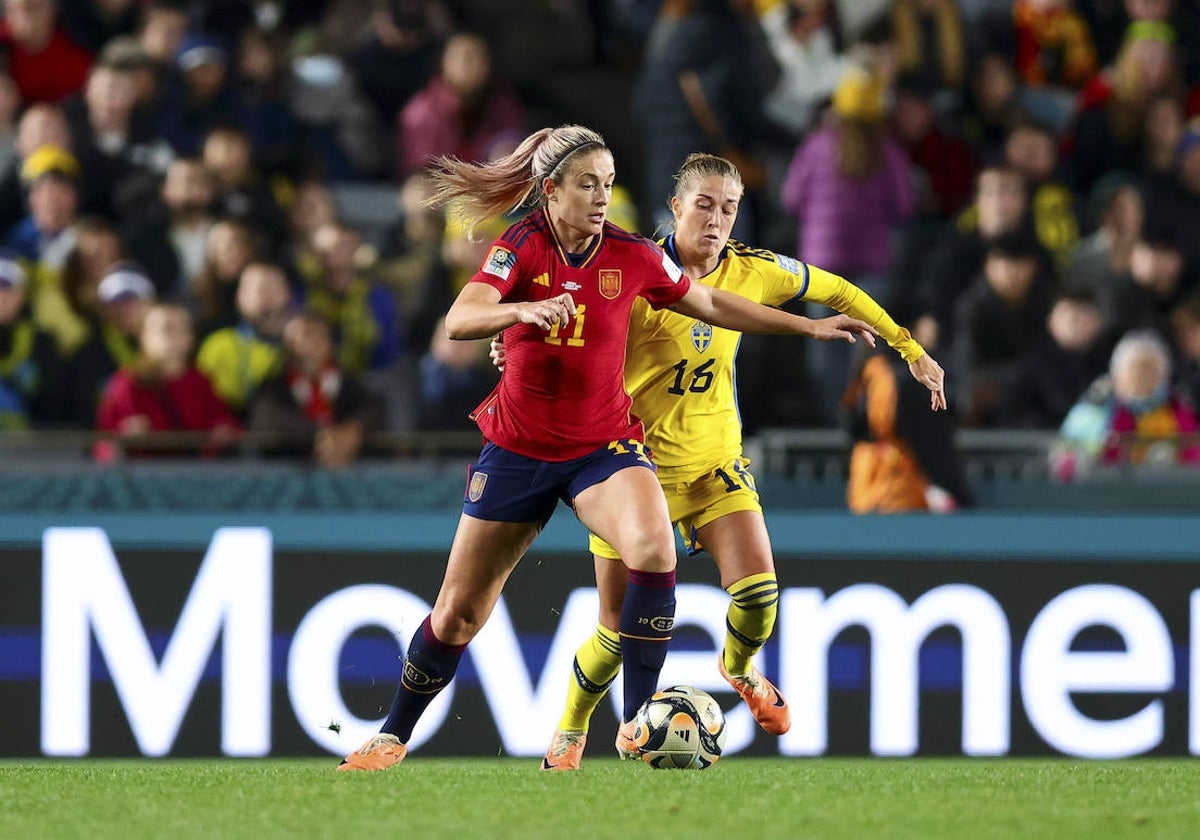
[634,685,725,770]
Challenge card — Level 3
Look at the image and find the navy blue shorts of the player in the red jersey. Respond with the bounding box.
[462,439,654,524]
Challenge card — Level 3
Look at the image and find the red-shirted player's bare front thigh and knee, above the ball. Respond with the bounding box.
[572,466,674,571]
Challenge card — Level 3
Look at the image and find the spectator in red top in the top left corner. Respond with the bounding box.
[0,0,92,103]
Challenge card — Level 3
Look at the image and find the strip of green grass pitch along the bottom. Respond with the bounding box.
[0,755,1200,840]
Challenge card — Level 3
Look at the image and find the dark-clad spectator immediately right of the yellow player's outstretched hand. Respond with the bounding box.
[950,232,1055,428]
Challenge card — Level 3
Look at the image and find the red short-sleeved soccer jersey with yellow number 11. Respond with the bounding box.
[470,210,691,461]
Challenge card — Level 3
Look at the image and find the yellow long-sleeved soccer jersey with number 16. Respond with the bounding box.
[625,238,925,474]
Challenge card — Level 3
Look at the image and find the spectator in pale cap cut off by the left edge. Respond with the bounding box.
[0,251,72,428]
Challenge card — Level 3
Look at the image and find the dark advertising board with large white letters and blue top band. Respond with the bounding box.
[0,511,1200,757]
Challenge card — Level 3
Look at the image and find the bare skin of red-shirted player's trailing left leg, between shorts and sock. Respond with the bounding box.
[433,514,539,644]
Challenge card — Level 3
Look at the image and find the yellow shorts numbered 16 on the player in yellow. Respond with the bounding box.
[588,457,762,560]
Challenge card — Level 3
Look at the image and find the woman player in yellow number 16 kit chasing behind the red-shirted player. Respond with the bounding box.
[525,154,946,770]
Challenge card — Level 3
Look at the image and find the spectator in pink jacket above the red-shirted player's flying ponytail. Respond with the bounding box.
[396,34,524,179]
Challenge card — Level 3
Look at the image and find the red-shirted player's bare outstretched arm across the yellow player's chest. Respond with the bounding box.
[670,283,878,347]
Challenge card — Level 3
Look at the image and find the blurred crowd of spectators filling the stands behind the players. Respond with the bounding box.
[0,0,1200,475]
